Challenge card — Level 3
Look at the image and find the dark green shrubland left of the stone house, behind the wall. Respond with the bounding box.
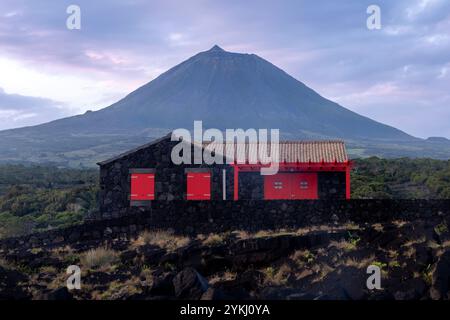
[0,165,98,238]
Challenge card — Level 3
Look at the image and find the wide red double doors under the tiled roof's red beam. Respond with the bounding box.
[264,173,318,200]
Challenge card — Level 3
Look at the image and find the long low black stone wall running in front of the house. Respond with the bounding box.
[0,199,450,250]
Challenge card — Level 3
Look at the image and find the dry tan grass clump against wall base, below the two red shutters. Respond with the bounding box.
[132,230,191,251]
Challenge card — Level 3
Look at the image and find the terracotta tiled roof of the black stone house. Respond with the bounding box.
[204,140,348,163]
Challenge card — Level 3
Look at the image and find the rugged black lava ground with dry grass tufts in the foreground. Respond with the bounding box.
[0,220,450,300]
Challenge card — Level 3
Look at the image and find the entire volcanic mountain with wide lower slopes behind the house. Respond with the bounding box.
[0,46,450,166]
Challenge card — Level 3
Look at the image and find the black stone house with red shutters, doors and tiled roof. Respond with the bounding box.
[98,134,351,212]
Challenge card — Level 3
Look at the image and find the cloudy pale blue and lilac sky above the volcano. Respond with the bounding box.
[0,0,450,138]
